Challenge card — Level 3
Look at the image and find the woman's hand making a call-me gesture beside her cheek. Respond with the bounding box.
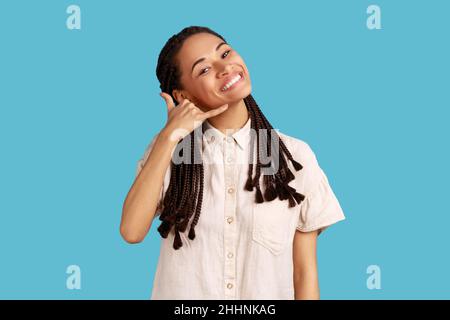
[160,92,228,141]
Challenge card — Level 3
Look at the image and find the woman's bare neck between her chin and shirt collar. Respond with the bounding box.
[208,99,250,135]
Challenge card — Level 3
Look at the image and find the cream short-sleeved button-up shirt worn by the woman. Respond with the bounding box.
[136,118,345,300]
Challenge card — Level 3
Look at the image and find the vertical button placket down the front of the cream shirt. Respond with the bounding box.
[223,137,237,299]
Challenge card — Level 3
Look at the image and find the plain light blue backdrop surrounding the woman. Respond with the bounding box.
[0,0,450,299]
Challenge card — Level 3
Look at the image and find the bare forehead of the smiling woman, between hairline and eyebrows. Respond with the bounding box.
[178,33,223,69]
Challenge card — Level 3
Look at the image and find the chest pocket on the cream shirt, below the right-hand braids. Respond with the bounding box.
[252,198,299,255]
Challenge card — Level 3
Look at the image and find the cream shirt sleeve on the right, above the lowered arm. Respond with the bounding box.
[297,142,345,235]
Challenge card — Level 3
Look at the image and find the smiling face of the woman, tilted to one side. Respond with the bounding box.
[173,33,252,110]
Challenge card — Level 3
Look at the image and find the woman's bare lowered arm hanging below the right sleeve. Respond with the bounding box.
[293,230,320,300]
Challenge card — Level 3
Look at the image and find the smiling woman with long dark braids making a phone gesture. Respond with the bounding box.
[120,26,345,299]
